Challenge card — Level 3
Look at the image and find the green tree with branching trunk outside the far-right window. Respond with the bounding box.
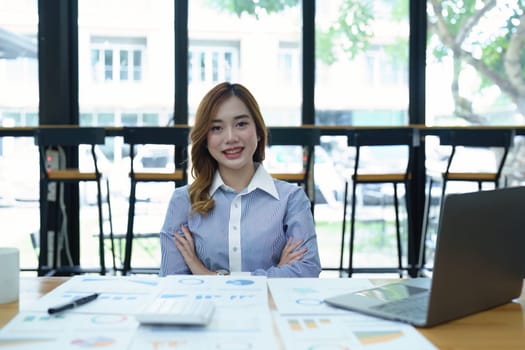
[428,0,525,124]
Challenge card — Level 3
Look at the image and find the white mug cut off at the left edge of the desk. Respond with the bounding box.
[0,247,20,304]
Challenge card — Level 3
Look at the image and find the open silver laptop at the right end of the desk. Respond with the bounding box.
[325,187,525,327]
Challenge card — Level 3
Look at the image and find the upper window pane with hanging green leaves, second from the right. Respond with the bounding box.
[315,0,409,126]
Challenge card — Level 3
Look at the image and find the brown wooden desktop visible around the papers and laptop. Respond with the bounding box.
[0,277,525,350]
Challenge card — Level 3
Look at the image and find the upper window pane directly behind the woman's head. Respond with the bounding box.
[188,0,302,125]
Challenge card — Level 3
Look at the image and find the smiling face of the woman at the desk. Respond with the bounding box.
[207,96,258,186]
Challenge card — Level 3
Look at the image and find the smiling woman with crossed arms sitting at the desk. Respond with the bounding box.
[160,83,321,277]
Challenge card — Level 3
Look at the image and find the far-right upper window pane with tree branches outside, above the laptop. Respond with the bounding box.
[426,0,525,125]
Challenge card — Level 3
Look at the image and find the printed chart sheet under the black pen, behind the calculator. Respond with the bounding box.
[23,275,268,315]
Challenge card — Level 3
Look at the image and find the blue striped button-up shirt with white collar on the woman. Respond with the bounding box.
[160,165,321,277]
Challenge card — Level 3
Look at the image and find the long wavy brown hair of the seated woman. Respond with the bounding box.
[189,82,268,215]
